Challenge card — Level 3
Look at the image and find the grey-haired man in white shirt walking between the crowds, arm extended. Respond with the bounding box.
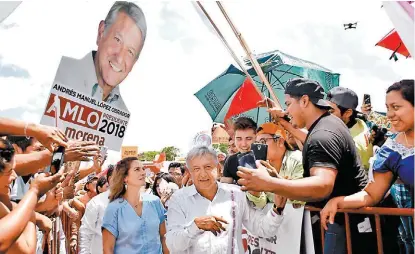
[166,146,286,254]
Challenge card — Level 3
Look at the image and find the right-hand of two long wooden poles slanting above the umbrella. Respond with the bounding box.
[216,1,282,109]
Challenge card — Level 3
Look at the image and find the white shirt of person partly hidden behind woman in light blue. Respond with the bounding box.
[79,191,109,254]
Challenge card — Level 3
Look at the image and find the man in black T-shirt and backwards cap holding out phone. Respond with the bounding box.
[238,79,367,253]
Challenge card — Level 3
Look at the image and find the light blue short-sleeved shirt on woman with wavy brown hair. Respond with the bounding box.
[102,193,166,254]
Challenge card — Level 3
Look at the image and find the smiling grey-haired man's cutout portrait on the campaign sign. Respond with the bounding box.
[55,1,147,109]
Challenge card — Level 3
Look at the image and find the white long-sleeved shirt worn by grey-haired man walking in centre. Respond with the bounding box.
[166,183,283,254]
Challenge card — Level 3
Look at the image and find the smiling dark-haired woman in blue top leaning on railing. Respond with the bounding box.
[321,80,414,253]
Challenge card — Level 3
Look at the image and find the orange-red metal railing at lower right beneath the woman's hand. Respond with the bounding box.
[305,206,415,254]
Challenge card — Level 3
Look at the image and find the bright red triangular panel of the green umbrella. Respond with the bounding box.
[225,78,262,121]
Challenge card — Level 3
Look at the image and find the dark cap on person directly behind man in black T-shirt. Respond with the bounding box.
[327,86,359,110]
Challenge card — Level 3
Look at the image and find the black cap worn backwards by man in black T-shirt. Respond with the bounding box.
[285,78,331,109]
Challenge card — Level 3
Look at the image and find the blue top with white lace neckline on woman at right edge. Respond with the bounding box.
[373,138,414,189]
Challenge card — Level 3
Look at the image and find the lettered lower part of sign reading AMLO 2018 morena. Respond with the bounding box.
[40,82,130,151]
